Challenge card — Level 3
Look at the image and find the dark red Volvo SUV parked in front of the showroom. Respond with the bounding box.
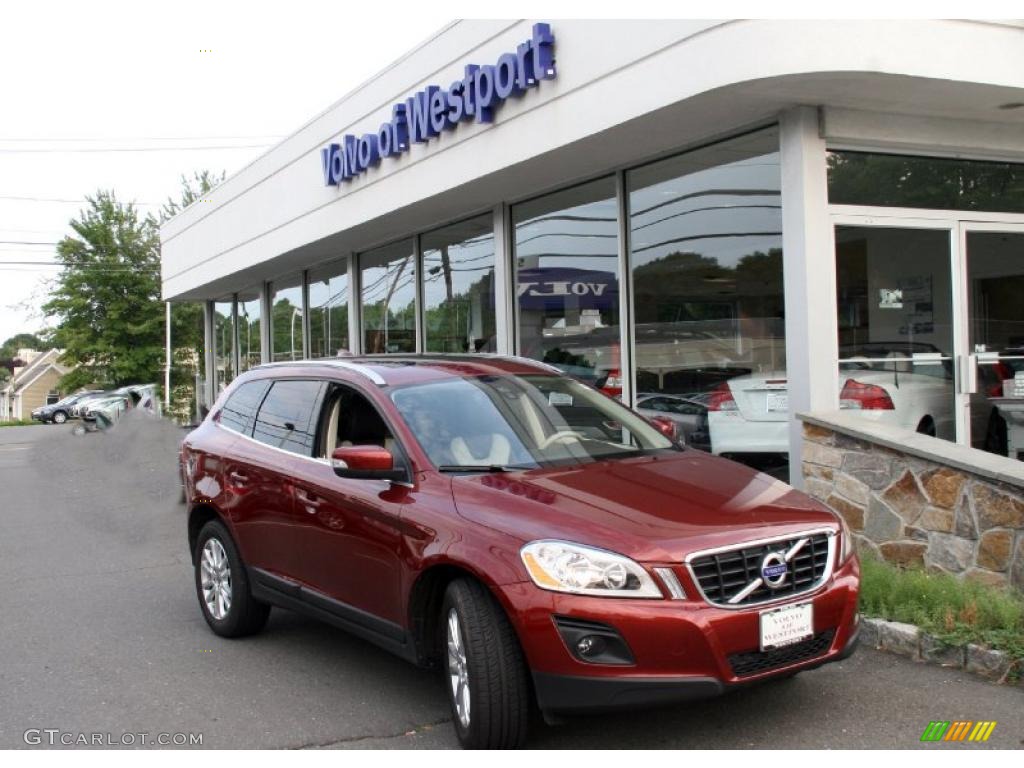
[181,355,859,746]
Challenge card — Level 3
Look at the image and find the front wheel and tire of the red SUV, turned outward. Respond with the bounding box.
[439,579,529,750]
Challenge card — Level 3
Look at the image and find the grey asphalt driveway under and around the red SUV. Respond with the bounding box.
[0,417,1024,750]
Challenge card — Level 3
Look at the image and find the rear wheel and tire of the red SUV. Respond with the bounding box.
[194,520,270,637]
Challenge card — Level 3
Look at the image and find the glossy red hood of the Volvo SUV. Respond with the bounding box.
[452,451,839,562]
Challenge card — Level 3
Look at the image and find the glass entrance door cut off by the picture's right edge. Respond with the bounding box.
[959,222,1024,459]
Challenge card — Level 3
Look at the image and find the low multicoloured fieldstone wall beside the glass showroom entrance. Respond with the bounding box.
[803,417,1024,589]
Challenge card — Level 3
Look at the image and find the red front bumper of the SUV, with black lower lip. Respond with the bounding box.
[499,557,860,714]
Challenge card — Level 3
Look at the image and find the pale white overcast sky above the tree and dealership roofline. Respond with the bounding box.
[0,0,450,342]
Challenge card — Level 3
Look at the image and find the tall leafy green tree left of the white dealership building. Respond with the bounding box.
[43,190,164,390]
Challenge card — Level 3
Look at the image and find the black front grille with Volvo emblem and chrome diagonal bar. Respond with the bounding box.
[689,534,829,607]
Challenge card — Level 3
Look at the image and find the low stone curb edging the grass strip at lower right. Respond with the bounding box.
[860,616,1024,685]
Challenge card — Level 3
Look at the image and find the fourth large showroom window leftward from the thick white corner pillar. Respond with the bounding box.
[359,240,416,354]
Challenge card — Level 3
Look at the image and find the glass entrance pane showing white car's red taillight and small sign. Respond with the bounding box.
[836,217,958,440]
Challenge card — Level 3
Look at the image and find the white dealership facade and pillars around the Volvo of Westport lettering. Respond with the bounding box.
[161,20,1024,479]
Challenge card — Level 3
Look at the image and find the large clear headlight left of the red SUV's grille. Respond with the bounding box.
[519,540,663,597]
